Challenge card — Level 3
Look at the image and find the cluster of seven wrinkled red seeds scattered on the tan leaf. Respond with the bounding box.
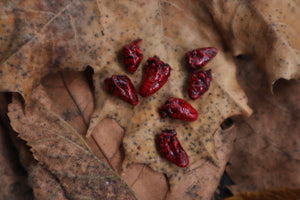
[104,39,217,167]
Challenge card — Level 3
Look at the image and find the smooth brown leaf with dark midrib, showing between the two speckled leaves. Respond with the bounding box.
[11,70,168,199]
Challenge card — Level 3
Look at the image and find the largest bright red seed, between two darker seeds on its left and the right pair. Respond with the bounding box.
[139,56,171,97]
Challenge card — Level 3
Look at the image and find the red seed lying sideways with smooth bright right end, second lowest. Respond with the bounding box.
[158,97,198,121]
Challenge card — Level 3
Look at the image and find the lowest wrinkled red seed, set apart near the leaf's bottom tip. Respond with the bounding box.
[157,129,189,167]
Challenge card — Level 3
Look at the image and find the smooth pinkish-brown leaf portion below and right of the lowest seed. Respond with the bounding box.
[163,129,236,200]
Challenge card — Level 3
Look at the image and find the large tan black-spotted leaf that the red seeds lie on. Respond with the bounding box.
[0,1,251,191]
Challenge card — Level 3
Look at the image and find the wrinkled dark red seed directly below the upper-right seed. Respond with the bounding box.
[188,69,212,100]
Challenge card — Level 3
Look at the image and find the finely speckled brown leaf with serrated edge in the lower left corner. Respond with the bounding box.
[8,90,136,199]
